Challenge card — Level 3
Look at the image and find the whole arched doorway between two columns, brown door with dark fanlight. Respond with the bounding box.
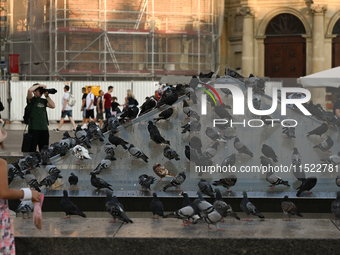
[264,13,306,86]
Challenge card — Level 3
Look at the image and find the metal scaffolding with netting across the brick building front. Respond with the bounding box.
[3,0,224,80]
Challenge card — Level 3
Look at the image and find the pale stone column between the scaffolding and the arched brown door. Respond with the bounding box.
[237,7,254,77]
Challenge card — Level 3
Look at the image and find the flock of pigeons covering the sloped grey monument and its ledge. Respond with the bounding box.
[8,71,340,228]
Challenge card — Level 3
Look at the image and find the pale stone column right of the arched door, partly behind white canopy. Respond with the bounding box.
[311,4,327,108]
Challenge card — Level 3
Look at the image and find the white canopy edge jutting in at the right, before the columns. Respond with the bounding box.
[298,66,340,88]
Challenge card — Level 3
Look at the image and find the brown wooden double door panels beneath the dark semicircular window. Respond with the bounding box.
[264,36,306,85]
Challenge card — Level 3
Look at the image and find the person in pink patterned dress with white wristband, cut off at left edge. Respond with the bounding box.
[0,154,41,254]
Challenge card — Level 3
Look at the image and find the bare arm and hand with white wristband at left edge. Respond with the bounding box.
[0,159,41,202]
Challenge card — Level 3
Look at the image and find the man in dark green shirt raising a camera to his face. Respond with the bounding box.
[27,84,55,152]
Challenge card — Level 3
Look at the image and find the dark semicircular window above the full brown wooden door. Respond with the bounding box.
[266,13,306,36]
